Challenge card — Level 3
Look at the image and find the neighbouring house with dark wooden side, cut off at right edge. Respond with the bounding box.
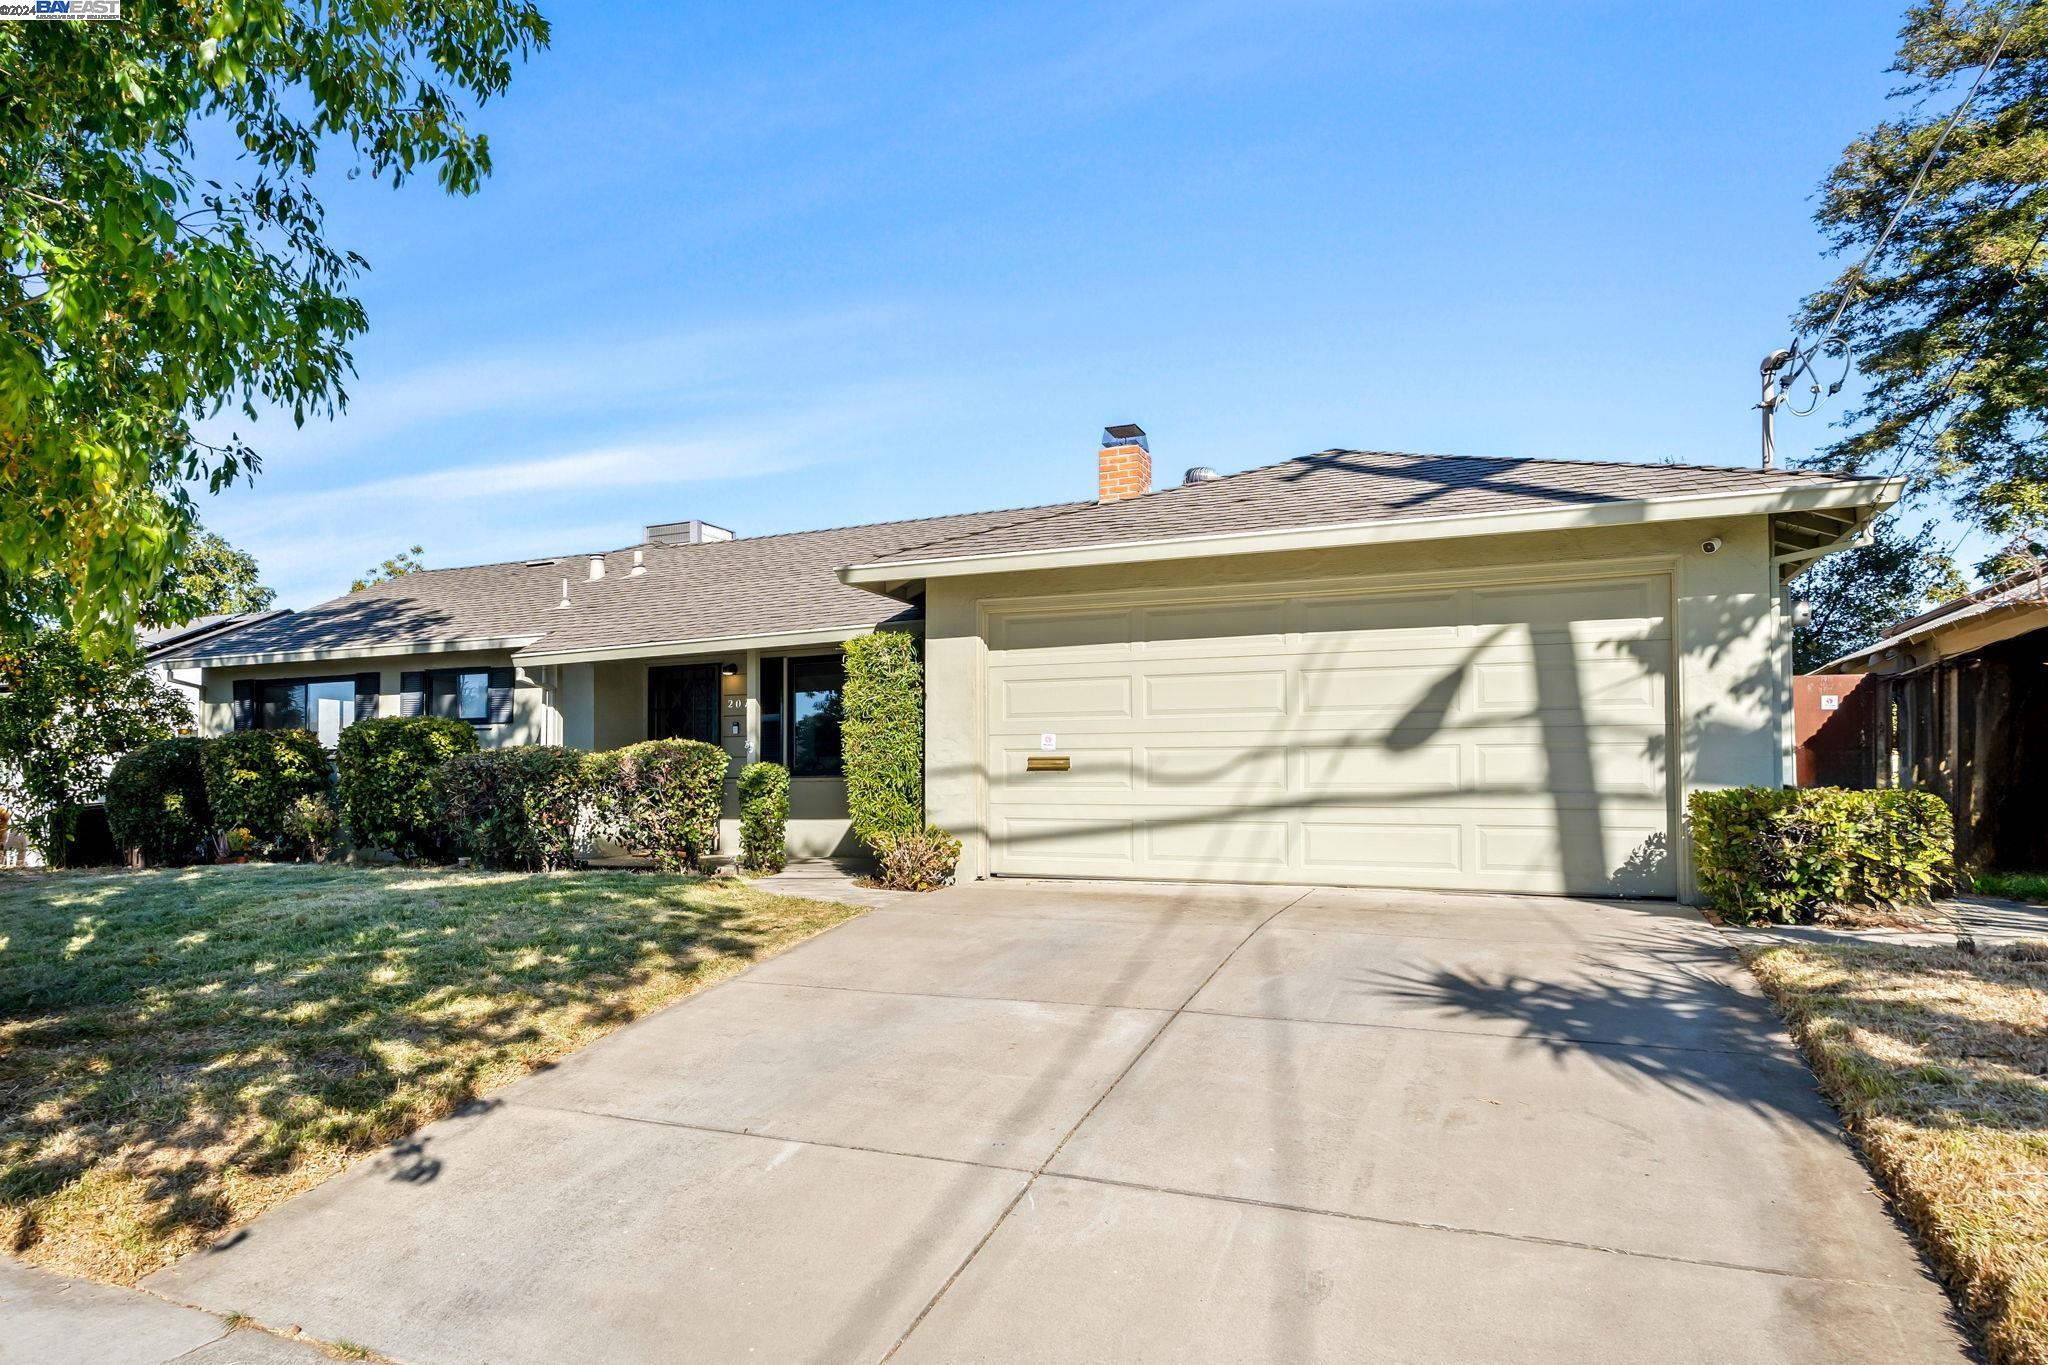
[1815,571,2048,872]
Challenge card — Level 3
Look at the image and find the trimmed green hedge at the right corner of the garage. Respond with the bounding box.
[1686,786,1956,925]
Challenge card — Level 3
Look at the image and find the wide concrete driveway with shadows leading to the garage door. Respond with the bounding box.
[150,882,1968,1363]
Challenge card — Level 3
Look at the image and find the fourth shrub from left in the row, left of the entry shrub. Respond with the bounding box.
[432,745,590,872]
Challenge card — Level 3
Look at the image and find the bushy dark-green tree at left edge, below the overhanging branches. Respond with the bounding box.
[0,630,193,857]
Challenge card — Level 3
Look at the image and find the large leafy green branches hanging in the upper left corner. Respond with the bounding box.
[0,0,549,653]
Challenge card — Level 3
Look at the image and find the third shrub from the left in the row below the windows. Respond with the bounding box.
[334,716,477,857]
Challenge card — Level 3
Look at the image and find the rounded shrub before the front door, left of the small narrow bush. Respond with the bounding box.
[590,739,731,872]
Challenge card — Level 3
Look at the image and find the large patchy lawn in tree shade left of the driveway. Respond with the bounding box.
[0,866,858,1281]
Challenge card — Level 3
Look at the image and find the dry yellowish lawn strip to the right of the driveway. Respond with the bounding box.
[1743,943,2048,1365]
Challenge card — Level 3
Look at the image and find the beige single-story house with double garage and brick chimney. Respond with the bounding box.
[163,426,1898,896]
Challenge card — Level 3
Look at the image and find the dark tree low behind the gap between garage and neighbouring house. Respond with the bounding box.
[1792,518,1964,673]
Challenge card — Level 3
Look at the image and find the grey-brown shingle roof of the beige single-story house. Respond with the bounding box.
[163,450,1890,663]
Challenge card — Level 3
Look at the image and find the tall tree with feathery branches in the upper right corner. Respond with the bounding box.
[1796,0,2048,538]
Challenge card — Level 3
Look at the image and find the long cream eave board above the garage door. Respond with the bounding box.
[840,479,1905,591]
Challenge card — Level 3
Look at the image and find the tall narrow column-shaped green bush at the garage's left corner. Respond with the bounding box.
[840,630,924,851]
